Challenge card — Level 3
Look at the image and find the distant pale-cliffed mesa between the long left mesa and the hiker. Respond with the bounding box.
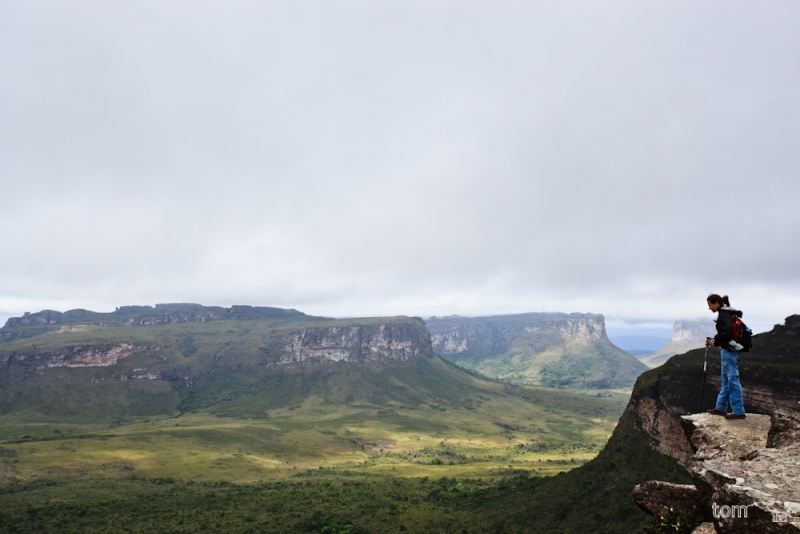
[425,313,647,389]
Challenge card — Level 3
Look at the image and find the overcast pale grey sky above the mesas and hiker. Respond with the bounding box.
[0,0,800,333]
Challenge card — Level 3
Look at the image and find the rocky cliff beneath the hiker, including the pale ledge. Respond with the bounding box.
[611,316,800,533]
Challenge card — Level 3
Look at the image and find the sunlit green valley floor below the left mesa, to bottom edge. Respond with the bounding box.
[0,388,622,534]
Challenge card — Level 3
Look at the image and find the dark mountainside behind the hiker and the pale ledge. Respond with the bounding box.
[456,315,800,534]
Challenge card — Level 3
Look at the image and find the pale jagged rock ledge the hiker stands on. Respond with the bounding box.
[633,412,800,534]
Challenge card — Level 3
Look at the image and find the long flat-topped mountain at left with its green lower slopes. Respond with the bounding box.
[0,304,615,439]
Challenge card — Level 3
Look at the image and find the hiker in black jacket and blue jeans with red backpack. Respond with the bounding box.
[706,293,746,419]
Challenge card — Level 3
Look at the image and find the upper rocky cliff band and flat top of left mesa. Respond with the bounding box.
[0,310,433,380]
